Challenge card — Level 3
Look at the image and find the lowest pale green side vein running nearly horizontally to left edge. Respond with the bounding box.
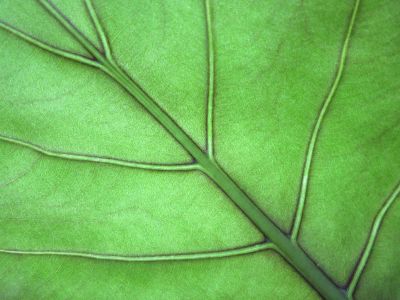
[0,243,274,262]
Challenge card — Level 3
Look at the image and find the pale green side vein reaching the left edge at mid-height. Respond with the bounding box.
[0,135,198,171]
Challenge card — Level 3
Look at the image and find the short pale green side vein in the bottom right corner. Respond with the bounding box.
[347,183,400,299]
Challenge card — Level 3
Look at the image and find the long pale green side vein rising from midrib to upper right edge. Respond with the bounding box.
[291,0,360,241]
